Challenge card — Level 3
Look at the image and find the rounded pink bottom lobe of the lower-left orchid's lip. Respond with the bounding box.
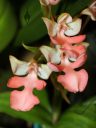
[10,89,39,111]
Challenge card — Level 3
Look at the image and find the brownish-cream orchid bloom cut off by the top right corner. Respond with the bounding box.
[81,0,96,21]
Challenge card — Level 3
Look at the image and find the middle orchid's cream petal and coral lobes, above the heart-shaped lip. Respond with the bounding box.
[40,45,87,71]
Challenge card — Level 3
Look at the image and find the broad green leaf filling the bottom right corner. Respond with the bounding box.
[54,97,96,128]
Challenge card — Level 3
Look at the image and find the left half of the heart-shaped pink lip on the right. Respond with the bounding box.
[57,71,78,93]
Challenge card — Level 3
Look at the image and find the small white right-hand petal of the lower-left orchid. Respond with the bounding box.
[37,64,52,80]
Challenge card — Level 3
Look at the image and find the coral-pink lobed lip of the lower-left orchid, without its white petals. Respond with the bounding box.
[8,71,46,111]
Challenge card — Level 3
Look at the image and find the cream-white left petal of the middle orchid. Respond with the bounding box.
[40,46,61,64]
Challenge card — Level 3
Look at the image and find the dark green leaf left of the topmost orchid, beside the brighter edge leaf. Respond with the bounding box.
[14,0,58,46]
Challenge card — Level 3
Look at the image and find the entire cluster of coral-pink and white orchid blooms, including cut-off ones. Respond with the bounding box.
[8,0,96,111]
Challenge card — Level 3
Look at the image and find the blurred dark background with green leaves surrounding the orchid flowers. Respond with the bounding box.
[0,0,96,128]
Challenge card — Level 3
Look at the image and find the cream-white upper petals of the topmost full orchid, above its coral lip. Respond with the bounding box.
[43,13,82,37]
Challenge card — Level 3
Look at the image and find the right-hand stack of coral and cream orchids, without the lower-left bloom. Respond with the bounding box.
[40,13,88,93]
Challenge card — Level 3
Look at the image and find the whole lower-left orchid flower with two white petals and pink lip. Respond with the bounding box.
[8,56,52,111]
